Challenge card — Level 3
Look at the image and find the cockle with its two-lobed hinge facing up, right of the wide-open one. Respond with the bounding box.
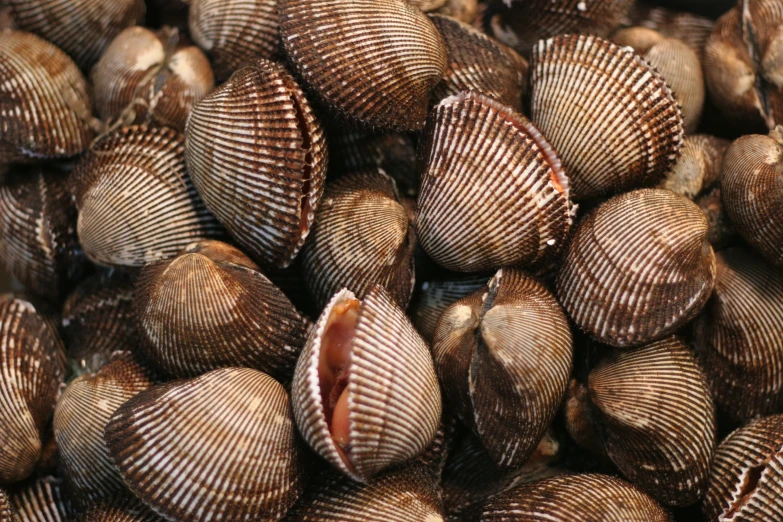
[432,269,573,469]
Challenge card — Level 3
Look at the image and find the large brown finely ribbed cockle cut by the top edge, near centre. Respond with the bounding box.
[278,0,448,131]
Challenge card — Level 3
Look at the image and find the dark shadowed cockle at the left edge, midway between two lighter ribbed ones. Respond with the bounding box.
[0,167,86,301]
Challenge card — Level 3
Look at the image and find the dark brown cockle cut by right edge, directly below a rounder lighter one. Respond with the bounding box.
[693,248,783,420]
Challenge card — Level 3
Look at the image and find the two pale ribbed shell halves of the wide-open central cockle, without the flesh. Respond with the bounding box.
[291,286,441,482]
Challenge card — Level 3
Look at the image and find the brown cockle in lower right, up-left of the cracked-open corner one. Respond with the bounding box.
[588,337,716,506]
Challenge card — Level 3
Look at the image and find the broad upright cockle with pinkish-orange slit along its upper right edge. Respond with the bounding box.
[416,92,571,272]
